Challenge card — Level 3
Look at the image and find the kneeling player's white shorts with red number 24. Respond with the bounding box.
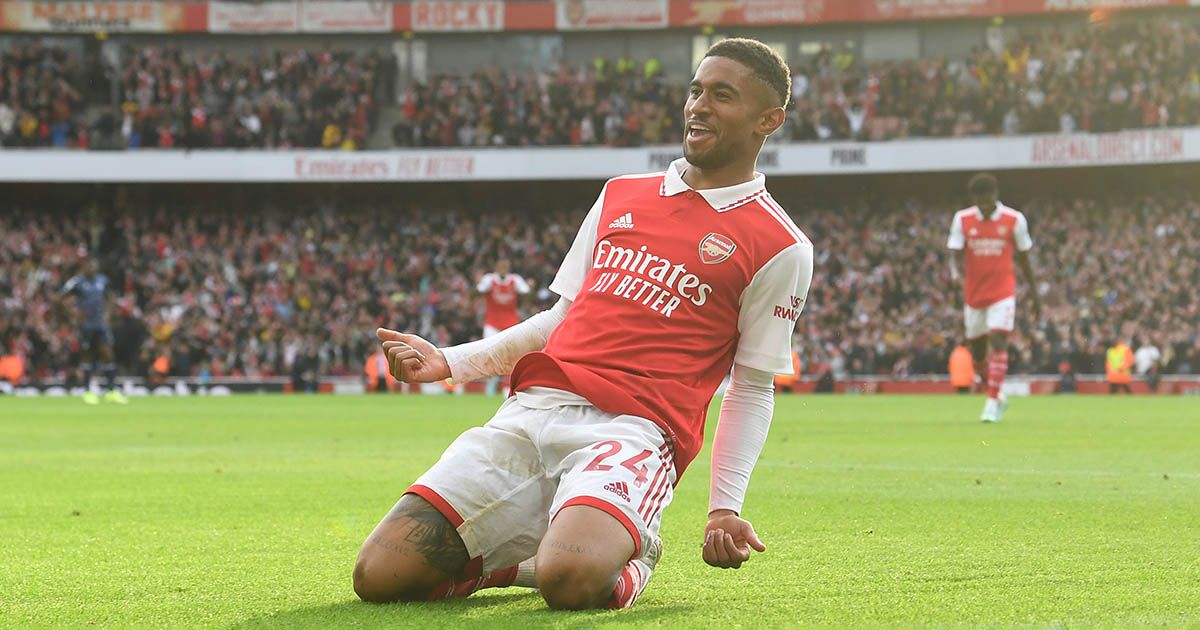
[408,396,676,575]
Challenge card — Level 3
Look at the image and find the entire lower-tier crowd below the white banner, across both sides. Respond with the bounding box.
[0,193,1200,378]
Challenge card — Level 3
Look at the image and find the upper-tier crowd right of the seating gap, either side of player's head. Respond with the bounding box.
[394,19,1200,146]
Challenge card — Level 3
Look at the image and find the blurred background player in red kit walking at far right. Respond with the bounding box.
[946,173,1042,422]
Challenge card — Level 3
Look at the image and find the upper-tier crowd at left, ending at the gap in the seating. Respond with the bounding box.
[0,44,395,150]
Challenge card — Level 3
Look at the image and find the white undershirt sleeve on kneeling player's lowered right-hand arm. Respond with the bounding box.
[708,364,775,514]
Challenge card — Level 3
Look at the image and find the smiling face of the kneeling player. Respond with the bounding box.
[683,56,784,169]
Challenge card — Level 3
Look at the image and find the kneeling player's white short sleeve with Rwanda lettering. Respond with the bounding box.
[733,242,812,374]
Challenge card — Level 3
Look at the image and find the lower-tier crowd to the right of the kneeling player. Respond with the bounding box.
[797,194,1200,378]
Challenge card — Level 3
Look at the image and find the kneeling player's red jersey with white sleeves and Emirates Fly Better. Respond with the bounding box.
[512,160,812,474]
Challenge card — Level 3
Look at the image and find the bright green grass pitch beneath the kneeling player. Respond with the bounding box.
[0,396,1200,628]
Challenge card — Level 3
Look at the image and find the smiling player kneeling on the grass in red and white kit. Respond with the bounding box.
[354,40,812,610]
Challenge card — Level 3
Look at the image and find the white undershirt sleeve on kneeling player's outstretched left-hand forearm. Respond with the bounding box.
[442,298,571,383]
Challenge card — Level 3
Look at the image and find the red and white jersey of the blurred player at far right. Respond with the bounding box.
[946,203,1033,308]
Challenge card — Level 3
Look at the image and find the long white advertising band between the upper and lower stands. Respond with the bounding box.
[0,127,1200,181]
